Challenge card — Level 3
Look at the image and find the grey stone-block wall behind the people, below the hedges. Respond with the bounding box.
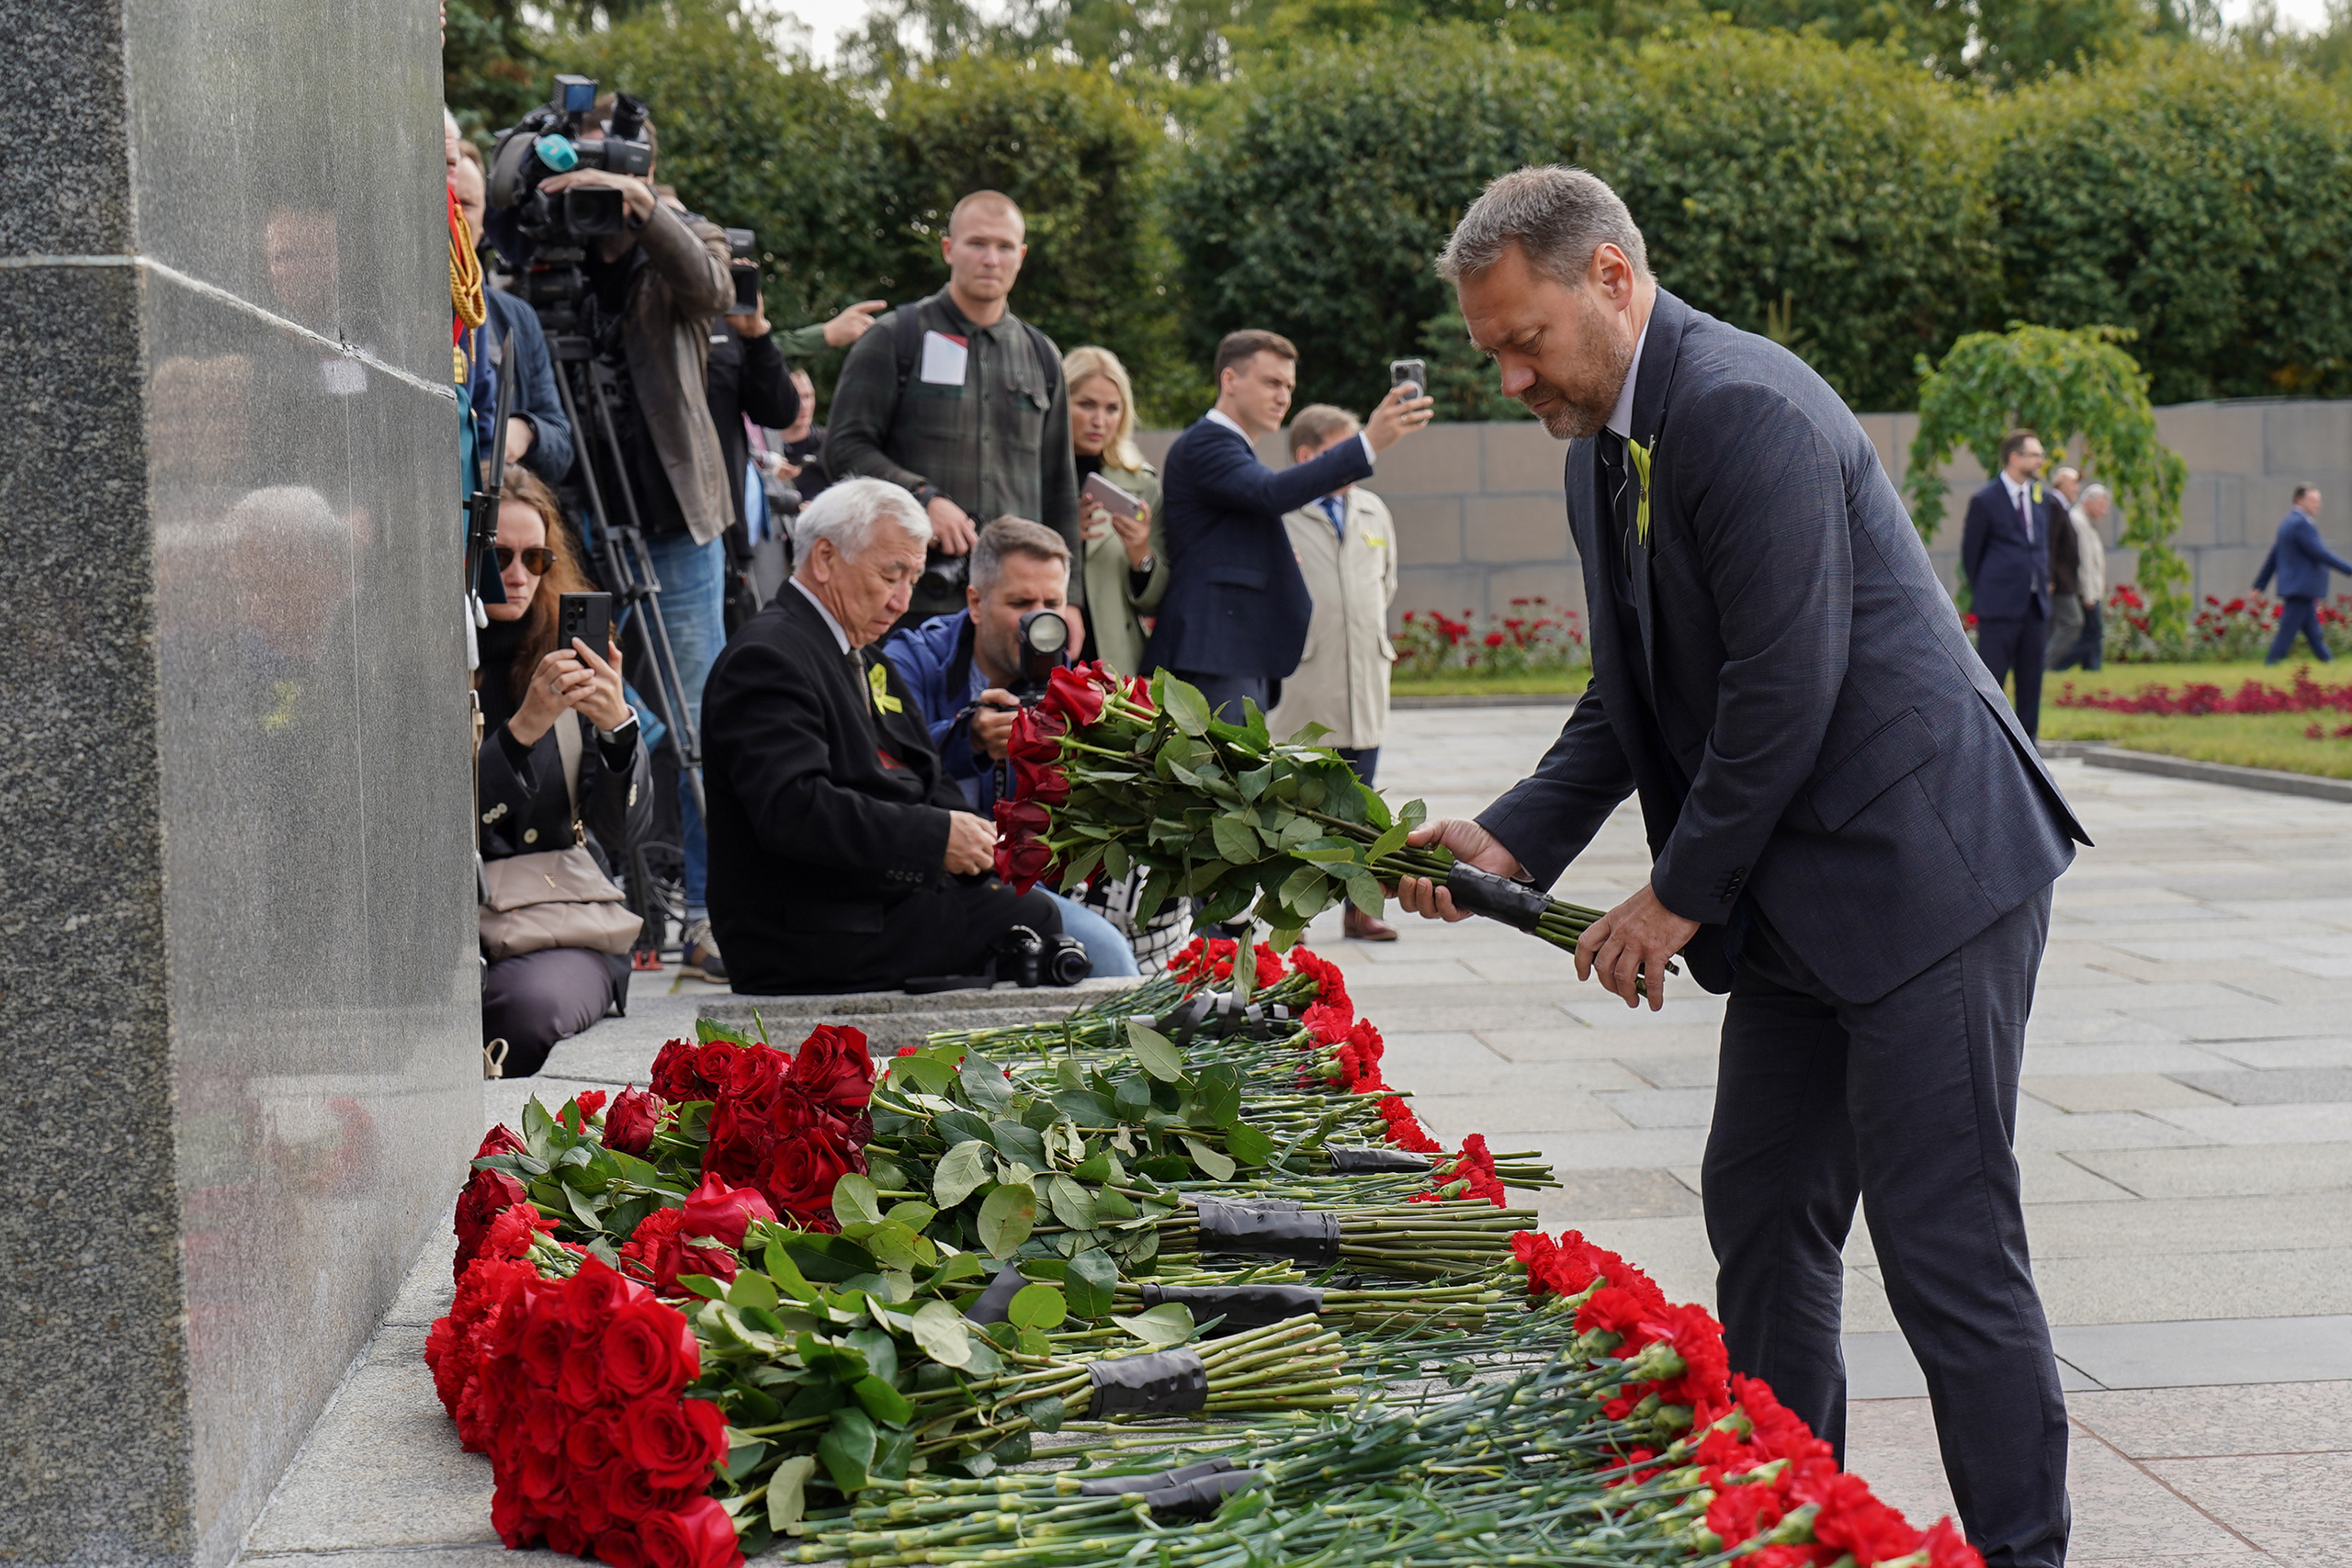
[1138,400,2352,614]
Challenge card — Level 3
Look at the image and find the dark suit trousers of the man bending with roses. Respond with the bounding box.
[1702,888,2070,1568]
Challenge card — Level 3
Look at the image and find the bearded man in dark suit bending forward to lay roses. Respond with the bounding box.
[1399,169,2088,1565]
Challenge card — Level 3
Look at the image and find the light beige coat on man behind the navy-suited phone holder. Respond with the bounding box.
[1265,484,1397,750]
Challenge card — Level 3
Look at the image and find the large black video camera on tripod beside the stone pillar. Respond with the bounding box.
[484,75,654,270]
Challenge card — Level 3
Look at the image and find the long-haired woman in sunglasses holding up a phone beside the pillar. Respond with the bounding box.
[473,468,654,1079]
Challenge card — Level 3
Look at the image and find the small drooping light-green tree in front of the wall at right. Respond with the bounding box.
[1907,322,2189,635]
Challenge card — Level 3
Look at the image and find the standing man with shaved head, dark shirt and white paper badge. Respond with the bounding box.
[826,190,1084,623]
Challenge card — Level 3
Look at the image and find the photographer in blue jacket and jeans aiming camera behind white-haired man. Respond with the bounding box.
[882,517,1138,976]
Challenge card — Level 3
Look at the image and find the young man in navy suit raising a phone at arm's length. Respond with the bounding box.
[1143,332,1432,724]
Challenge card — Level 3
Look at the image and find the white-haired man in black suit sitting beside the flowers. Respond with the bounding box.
[703,479,1061,995]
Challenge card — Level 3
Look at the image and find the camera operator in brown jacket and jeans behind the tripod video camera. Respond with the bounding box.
[538,94,743,978]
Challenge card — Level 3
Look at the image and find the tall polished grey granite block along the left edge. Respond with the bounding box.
[0,0,480,1568]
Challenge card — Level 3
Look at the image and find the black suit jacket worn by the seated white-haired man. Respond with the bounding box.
[703,583,969,983]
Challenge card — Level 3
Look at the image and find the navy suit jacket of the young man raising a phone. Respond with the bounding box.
[1143,419,1371,680]
